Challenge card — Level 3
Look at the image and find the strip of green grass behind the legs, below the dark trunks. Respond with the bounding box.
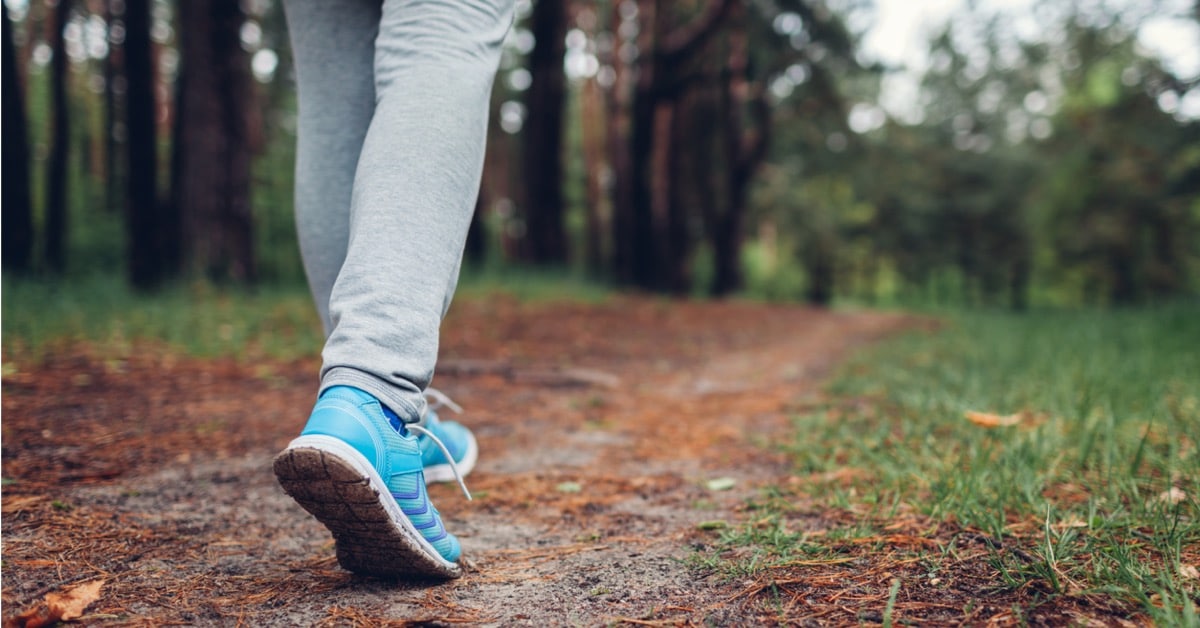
[0,269,610,361]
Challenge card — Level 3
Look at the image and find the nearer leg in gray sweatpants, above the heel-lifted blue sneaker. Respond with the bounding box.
[322,0,514,421]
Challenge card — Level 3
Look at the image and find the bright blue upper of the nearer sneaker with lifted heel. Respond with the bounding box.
[301,385,462,562]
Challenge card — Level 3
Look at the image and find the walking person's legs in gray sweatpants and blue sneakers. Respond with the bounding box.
[274,0,512,578]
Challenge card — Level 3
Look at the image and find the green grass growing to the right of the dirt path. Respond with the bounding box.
[702,305,1200,626]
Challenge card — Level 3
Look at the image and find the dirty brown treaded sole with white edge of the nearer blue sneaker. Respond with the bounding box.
[274,436,462,579]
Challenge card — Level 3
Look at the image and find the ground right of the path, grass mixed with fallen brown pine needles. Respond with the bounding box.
[694,305,1200,626]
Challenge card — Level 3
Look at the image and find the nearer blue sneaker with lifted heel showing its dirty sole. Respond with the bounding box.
[275,385,470,578]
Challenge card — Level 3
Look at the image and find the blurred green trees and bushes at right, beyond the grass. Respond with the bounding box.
[748,5,1200,309]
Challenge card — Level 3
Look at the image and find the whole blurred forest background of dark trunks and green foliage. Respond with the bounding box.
[2,0,1200,309]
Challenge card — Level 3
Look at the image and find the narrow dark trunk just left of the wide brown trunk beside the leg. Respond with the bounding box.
[124,0,169,289]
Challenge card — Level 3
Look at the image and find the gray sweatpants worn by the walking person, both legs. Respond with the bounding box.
[284,0,514,420]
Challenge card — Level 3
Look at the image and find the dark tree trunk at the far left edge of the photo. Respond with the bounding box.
[2,5,34,273]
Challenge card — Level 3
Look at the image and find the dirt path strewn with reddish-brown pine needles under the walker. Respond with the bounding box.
[2,298,907,626]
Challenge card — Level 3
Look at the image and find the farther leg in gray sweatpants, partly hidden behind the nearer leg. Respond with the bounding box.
[283,0,380,336]
